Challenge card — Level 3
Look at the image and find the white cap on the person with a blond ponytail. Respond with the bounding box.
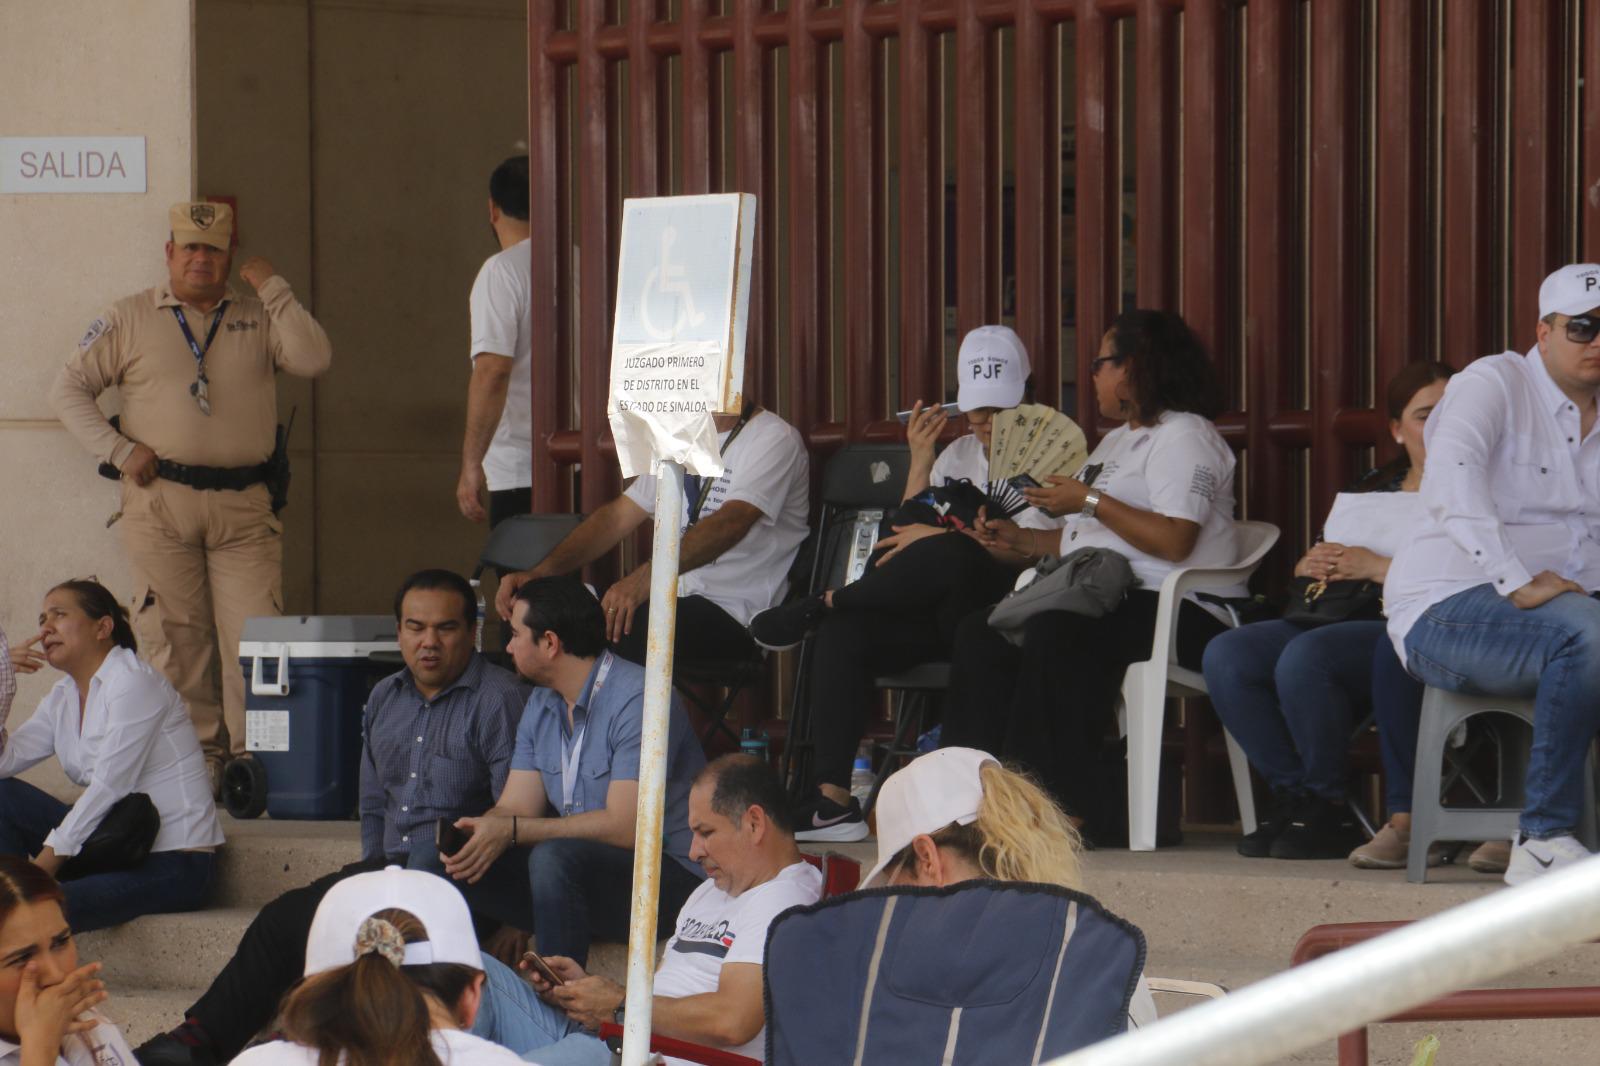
[861,747,1000,887]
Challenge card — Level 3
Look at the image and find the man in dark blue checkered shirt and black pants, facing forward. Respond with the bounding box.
[138,570,528,1066]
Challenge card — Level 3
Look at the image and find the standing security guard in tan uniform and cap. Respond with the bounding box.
[51,203,333,784]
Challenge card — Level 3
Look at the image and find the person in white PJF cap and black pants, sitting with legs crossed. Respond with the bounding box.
[750,325,1086,840]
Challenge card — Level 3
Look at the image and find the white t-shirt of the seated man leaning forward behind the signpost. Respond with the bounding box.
[626,411,810,626]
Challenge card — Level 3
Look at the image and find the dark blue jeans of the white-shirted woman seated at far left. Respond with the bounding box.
[0,778,216,933]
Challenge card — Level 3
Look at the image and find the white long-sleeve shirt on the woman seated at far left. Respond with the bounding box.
[0,648,222,856]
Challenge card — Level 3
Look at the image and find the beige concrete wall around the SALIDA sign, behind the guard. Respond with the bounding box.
[0,0,195,719]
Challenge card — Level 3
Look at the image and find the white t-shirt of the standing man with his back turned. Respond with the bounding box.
[469,240,533,493]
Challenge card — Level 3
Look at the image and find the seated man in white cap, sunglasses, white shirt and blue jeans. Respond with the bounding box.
[1384,262,1600,885]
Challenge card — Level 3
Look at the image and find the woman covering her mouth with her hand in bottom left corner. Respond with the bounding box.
[0,855,136,1066]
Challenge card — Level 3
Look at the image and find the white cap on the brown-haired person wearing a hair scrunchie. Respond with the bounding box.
[306,866,483,976]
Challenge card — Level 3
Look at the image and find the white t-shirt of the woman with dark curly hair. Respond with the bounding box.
[1061,411,1245,595]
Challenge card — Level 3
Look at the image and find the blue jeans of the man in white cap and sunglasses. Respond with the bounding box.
[1405,584,1600,839]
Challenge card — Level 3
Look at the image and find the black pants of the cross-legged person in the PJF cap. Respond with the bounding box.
[806,533,1016,787]
